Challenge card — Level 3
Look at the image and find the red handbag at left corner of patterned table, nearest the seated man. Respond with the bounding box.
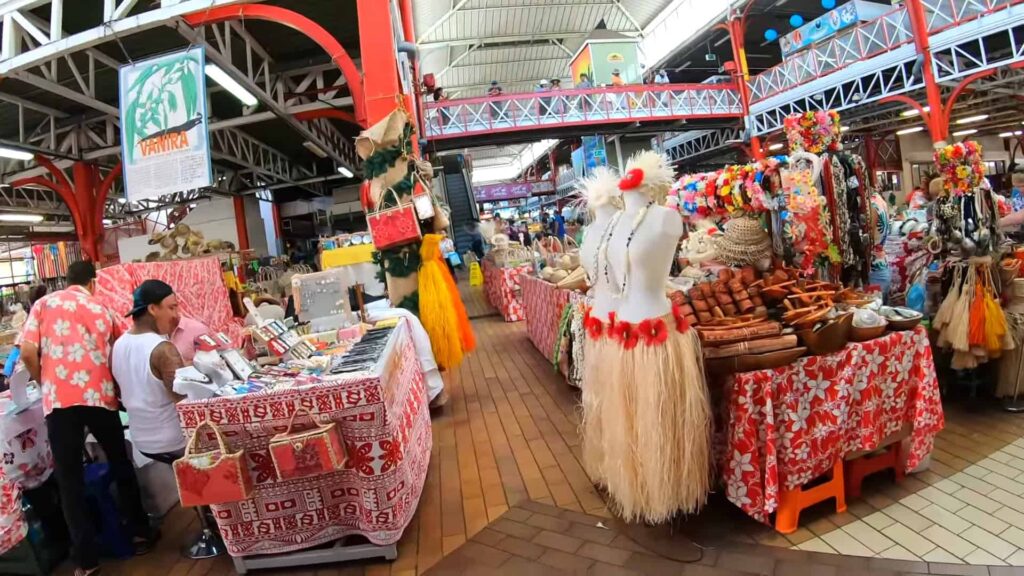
[174,422,253,506]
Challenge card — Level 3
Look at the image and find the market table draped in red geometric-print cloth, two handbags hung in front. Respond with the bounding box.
[178,320,431,573]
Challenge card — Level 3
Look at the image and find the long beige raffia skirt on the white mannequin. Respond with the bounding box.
[582,316,713,524]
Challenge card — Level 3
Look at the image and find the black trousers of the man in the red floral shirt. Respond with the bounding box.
[46,406,150,570]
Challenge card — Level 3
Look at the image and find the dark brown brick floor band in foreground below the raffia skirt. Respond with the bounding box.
[425,502,1024,576]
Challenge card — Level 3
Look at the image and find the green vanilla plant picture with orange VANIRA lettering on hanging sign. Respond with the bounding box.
[121,51,205,163]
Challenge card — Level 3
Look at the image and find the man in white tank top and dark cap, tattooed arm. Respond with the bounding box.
[111,280,185,463]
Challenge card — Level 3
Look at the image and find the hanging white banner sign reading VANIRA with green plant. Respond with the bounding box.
[118,46,213,202]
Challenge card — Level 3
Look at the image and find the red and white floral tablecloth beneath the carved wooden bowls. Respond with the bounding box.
[719,327,944,522]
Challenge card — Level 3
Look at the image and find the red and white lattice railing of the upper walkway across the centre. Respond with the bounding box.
[423,84,742,139]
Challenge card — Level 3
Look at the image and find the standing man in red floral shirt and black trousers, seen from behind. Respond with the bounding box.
[22,261,153,576]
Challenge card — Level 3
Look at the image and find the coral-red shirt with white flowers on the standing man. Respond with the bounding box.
[22,286,119,414]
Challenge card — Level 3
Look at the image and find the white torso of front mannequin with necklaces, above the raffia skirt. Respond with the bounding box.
[594,192,683,323]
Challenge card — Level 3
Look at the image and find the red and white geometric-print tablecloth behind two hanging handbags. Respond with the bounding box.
[178,321,431,557]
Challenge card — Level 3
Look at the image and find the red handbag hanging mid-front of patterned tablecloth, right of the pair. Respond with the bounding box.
[270,408,345,480]
